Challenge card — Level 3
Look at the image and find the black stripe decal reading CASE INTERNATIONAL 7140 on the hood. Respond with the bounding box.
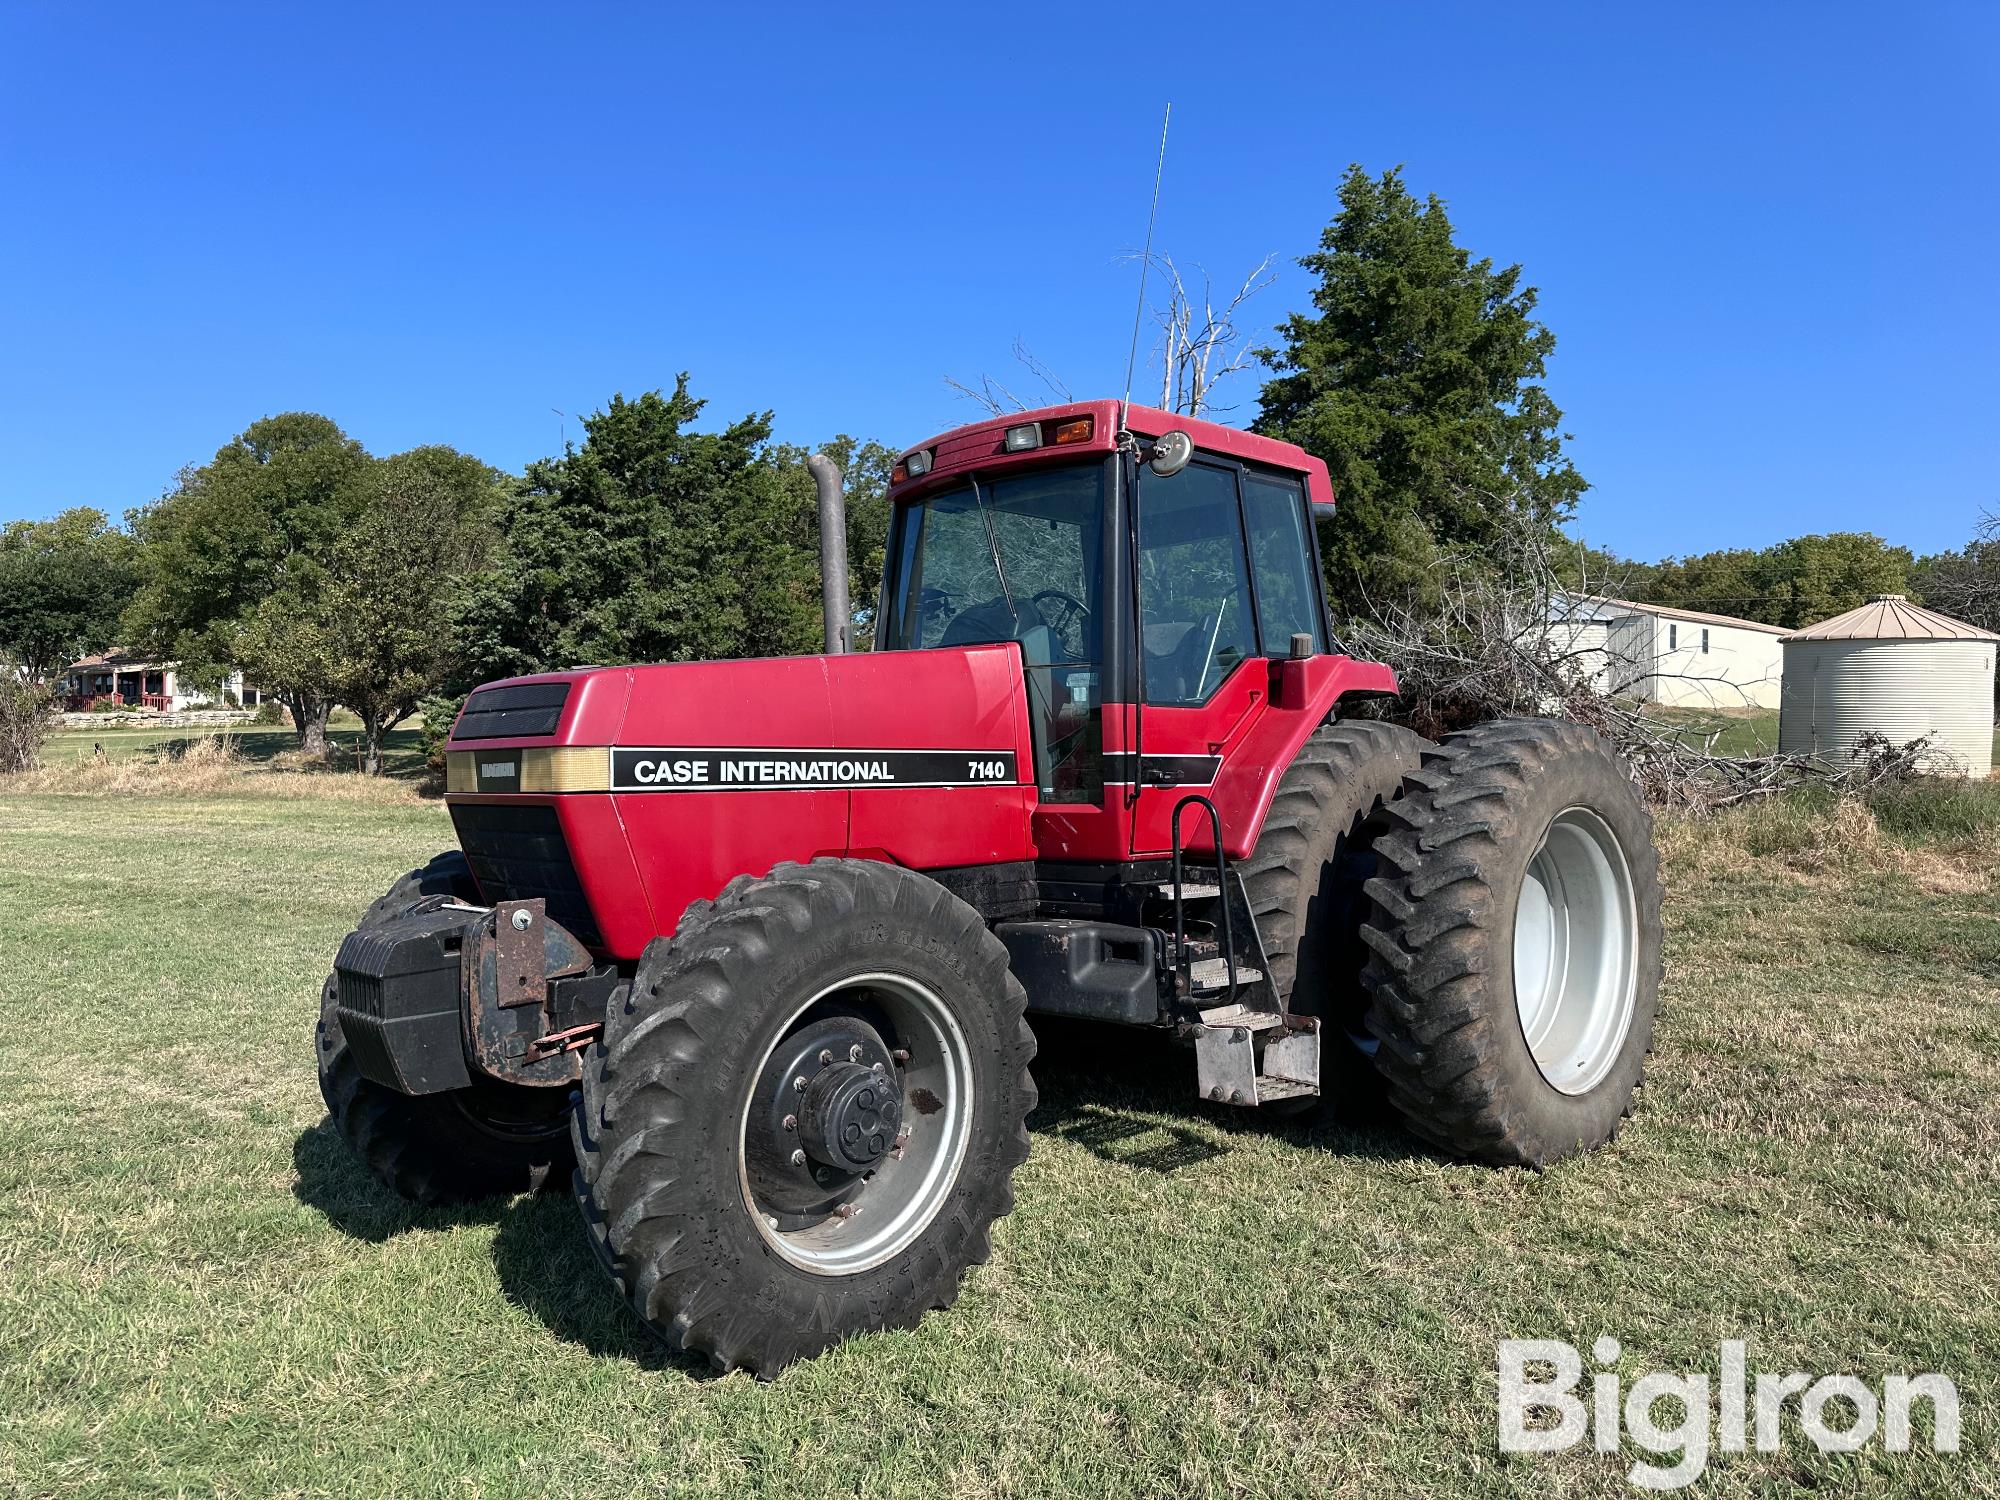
[612,746,1014,792]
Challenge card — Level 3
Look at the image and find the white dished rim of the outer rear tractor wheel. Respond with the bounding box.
[1514,808,1638,1094]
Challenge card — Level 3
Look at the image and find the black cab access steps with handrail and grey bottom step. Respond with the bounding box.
[1172,794,1320,1108]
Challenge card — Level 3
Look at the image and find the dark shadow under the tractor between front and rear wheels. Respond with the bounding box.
[1028,1016,1434,1176]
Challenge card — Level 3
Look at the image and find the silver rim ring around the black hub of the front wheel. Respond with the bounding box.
[736,974,972,1276]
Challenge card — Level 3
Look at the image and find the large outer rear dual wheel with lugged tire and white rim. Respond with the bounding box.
[1362,720,1660,1166]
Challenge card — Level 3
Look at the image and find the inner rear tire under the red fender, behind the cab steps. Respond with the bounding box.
[1240,720,1434,1114]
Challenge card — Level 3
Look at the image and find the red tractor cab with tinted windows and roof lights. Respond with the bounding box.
[876,400,1394,860]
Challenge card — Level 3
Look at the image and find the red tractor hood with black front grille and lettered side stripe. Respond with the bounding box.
[446,642,1036,958]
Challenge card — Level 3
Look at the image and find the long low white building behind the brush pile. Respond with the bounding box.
[1554,596,1786,708]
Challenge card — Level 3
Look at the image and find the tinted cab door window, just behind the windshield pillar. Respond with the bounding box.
[1138,464,1256,706]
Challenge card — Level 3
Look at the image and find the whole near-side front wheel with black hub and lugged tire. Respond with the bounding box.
[574,860,1034,1376]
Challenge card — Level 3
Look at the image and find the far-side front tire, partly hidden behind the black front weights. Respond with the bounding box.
[314,850,570,1204]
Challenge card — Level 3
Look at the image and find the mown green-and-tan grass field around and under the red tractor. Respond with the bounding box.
[0,776,2000,1496]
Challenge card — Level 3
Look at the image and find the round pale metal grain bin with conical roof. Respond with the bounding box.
[1778,594,2000,776]
